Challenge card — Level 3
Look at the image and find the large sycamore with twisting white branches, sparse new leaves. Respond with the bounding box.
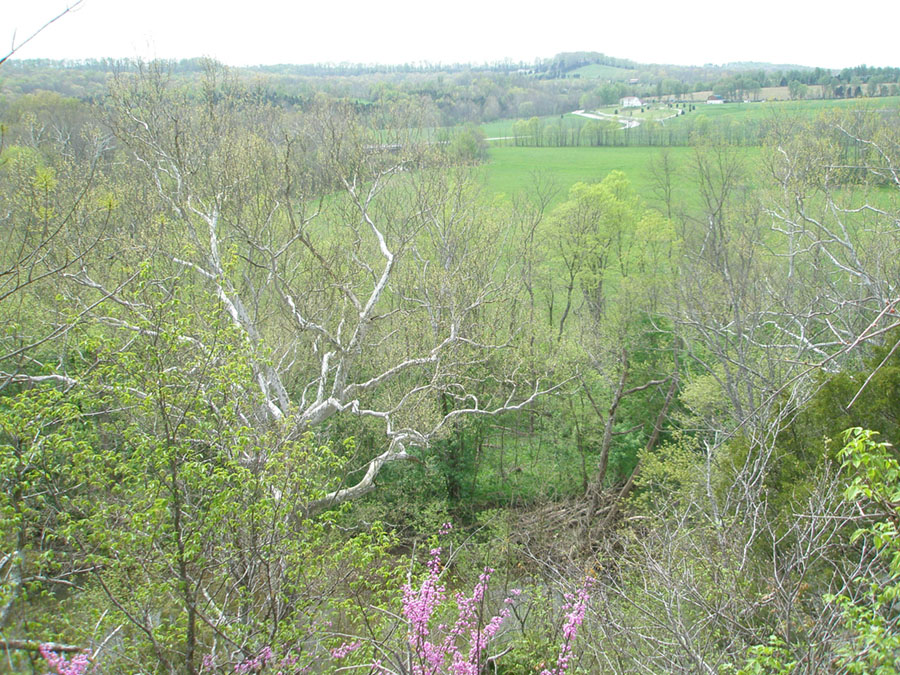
[59,66,552,507]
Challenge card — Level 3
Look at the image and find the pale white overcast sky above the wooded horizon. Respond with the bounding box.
[7,0,900,68]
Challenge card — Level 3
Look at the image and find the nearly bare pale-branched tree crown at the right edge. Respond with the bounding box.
[766,109,900,404]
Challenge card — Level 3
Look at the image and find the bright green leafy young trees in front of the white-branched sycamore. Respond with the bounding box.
[0,277,408,672]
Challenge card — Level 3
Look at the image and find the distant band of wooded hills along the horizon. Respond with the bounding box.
[0,52,900,126]
